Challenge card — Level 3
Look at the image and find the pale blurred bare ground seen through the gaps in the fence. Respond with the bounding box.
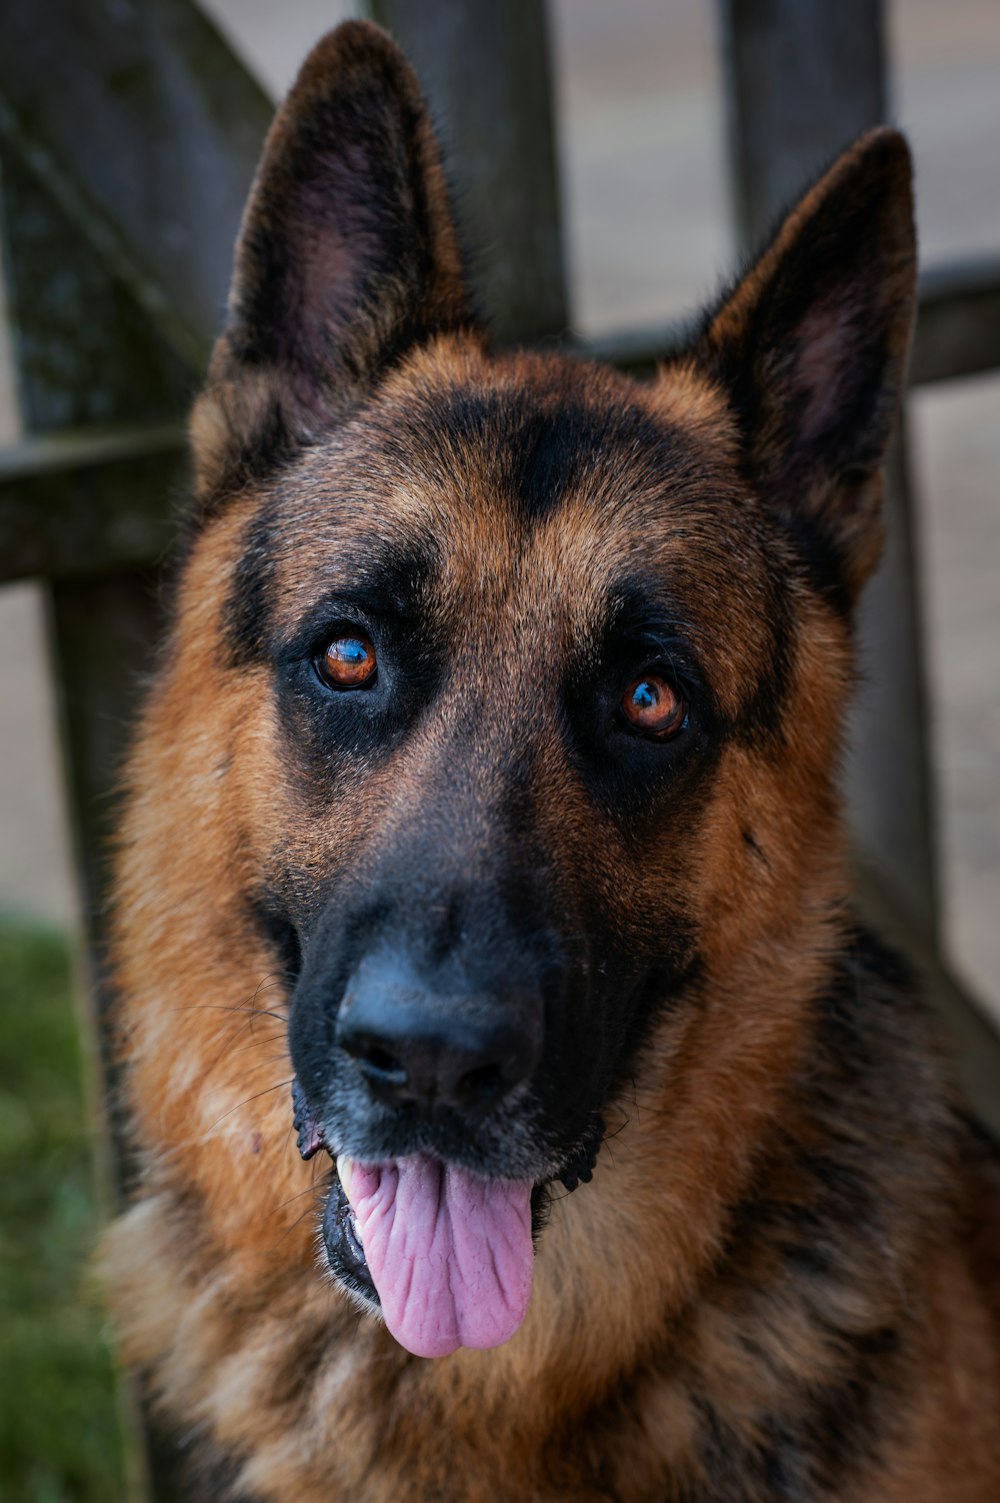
[0,0,1000,1019]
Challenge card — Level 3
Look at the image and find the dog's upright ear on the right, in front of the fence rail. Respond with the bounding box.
[695,128,916,603]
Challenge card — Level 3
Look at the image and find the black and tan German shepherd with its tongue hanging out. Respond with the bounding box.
[107,23,1000,1503]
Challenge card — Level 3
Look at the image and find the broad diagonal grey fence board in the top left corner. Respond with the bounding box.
[0,0,274,370]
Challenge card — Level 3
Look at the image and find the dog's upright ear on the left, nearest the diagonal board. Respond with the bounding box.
[191,21,472,514]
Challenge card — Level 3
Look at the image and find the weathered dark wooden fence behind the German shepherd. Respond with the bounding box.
[0,0,1000,1498]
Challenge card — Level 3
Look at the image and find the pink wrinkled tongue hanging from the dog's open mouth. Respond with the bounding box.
[337,1153,534,1357]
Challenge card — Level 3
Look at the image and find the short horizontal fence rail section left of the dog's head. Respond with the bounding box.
[0,424,188,582]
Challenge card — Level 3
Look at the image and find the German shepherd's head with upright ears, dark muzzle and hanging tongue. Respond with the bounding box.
[169,26,913,1354]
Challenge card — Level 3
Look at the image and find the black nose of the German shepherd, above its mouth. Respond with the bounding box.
[337,963,540,1118]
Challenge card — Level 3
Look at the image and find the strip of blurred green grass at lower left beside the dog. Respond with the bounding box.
[0,924,125,1503]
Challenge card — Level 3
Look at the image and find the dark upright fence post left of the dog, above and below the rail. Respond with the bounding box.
[0,156,179,1503]
